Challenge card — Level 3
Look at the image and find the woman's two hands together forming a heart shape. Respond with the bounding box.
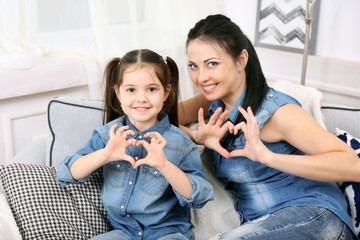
[192,106,269,161]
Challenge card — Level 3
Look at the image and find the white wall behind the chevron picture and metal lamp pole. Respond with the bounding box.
[225,0,360,107]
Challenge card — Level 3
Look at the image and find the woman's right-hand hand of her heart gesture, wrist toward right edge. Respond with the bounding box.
[229,106,271,162]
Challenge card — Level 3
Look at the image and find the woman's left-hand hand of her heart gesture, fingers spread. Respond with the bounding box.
[193,107,234,158]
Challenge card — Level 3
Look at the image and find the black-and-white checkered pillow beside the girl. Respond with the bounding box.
[0,163,111,239]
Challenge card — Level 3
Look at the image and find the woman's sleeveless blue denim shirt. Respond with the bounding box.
[208,89,353,232]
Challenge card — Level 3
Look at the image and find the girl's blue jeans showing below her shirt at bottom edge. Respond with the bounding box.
[90,229,195,240]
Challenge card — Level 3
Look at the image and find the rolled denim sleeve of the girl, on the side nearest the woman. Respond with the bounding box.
[175,143,214,208]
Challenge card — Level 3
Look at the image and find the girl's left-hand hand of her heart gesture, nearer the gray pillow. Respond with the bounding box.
[104,124,136,166]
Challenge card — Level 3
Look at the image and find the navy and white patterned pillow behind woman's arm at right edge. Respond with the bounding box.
[335,128,360,237]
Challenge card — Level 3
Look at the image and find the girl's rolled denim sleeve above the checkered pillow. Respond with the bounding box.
[56,130,105,187]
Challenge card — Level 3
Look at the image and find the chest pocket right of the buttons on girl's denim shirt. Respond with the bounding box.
[140,165,168,196]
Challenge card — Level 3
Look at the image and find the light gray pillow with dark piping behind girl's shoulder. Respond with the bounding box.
[46,97,104,167]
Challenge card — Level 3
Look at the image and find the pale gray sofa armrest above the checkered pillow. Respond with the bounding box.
[6,138,47,165]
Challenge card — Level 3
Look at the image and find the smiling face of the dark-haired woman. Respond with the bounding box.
[187,39,246,108]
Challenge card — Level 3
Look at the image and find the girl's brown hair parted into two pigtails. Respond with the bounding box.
[103,49,179,126]
